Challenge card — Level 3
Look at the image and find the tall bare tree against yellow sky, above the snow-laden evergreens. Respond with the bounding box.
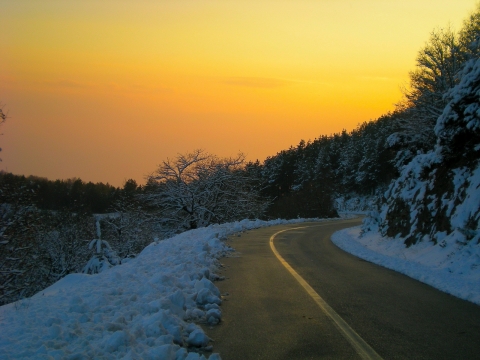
[387,28,464,168]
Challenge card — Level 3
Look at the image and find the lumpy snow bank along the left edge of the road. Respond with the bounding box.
[0,220,326,360]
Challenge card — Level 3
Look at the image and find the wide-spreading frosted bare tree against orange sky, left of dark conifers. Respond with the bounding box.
[147,150,265,231]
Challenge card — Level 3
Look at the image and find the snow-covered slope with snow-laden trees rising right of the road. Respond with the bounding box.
[352,59,480,304]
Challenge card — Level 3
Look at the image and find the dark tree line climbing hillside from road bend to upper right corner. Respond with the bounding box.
[251,4,480,225]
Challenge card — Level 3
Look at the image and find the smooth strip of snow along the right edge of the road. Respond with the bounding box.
[332,226,480,305]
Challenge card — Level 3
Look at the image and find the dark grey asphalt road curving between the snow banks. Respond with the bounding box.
[205,220,480,360]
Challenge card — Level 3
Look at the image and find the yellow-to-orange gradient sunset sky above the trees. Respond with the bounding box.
[0,0,476,186]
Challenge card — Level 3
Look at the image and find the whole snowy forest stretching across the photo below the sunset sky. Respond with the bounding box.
[0,6,480,305]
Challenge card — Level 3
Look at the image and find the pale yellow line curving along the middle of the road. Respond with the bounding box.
[270,225,381,359]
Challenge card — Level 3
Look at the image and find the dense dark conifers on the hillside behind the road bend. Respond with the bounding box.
[260,114,397,217]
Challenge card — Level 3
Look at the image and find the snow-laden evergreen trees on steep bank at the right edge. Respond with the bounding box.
[379,53,480,245]
